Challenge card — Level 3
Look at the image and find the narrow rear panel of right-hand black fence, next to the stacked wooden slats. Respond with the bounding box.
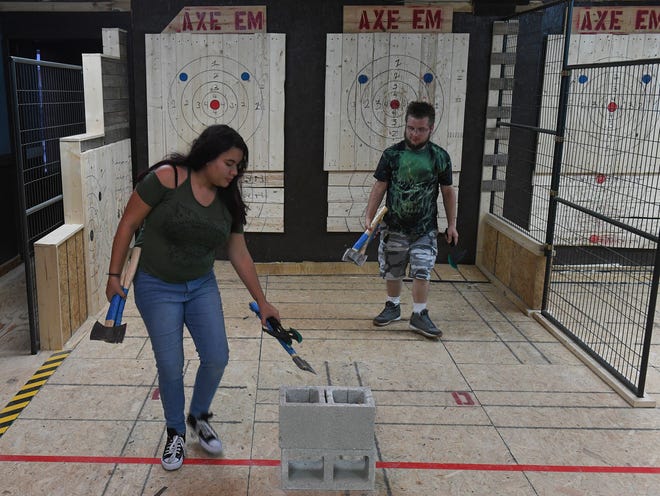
[491,5,565,242]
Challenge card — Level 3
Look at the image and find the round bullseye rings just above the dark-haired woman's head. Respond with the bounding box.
[167,56,266,144]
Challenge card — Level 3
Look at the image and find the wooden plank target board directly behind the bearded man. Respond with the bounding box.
[323,33,469,232]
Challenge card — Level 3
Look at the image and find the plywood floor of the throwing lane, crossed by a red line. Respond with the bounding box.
[0,262,660,496]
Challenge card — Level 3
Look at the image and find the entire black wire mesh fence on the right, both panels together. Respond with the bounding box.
[484,1,660,396]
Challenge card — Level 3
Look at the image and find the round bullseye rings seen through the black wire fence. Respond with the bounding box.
[570,66,660,155]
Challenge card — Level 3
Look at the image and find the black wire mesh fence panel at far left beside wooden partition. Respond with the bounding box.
[11,57,85,354]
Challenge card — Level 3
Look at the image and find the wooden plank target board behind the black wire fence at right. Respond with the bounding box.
[532,34,660,248]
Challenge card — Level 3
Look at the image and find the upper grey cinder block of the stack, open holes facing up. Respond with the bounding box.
[279,386,376,450]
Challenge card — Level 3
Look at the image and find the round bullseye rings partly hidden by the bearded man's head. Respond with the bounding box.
[346,55,444,151]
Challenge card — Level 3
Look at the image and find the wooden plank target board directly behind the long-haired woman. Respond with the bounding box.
[145,33,285,232]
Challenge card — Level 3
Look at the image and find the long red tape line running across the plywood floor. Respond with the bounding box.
[0,455,660,474]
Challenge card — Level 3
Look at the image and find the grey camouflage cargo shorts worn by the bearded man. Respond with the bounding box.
[378,229,438,281]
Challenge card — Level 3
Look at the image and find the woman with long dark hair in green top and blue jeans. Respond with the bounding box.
[106,125,279,470]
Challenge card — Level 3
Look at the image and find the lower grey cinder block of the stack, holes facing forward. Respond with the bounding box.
[281,448,376,491]
